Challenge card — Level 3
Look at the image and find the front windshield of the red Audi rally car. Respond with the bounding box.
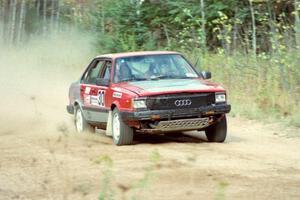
[113,54,198,83]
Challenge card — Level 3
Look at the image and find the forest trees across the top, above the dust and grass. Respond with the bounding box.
[0,0,300,53]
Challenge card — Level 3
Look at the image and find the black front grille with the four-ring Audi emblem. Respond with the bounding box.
[147,93,215,110]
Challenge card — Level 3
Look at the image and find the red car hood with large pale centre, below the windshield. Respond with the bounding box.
[119,79,225,96]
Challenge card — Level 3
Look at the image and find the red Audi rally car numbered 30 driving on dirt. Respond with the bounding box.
[67,51,230,145]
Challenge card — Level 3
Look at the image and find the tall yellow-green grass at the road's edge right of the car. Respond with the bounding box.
[188,50,300,127]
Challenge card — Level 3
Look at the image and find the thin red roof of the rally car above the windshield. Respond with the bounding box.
[96,51,181,59]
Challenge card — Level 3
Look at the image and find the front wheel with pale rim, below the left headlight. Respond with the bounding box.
[111,108,133,146]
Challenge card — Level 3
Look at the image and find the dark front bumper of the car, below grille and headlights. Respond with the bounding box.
[120,104,231,121]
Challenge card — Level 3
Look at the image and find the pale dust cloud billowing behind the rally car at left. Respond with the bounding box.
[0,31,95,134]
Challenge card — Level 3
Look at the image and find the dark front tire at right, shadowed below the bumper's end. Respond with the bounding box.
[205,116,227,142]
